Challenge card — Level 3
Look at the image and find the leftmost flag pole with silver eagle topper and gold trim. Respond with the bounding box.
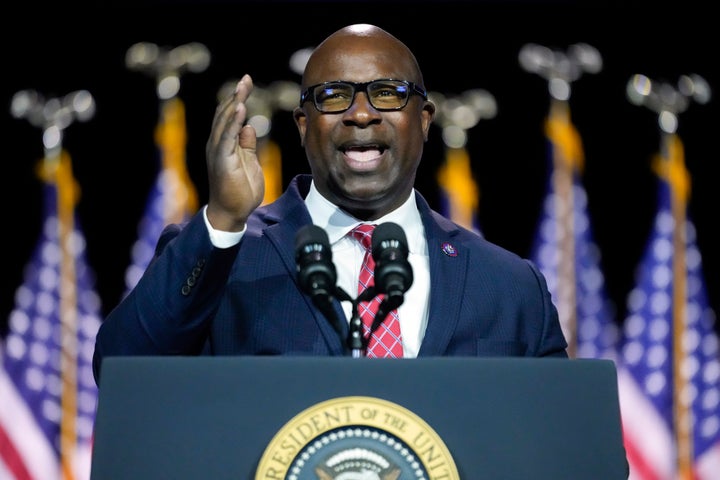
[11,90,95,480]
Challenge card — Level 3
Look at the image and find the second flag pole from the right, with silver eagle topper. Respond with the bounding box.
[518,43,602,357]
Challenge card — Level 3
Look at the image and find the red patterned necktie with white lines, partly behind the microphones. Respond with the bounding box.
[350,224,403,358]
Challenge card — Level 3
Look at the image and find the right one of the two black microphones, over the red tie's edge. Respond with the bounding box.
[372,222,413,311]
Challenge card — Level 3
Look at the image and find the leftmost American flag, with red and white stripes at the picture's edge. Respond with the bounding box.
[0,152,101,480]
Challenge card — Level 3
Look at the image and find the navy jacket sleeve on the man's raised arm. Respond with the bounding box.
[93,212,238,381]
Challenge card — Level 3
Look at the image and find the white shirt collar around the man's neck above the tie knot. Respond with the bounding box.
[305,181,426,253]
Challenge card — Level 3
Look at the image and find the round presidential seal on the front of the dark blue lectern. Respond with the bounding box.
[255,396,460,480]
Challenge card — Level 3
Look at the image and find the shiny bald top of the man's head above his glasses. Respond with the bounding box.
[302,23,424,88]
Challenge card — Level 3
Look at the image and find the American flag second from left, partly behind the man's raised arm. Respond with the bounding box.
[125,97,198,294]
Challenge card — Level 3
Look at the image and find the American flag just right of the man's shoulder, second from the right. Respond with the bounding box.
[530,100,619,359]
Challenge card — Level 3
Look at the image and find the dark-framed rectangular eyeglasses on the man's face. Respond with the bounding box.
[300,78,427,113]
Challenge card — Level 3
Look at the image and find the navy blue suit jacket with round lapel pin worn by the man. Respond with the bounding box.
[93,175,567,379]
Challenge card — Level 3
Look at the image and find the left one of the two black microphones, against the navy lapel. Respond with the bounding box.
[295,224,337,310]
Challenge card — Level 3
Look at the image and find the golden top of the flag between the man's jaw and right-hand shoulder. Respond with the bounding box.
[437,147,481,233]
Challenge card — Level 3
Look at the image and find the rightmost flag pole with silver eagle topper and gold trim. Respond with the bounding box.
[626,74,710,480]
